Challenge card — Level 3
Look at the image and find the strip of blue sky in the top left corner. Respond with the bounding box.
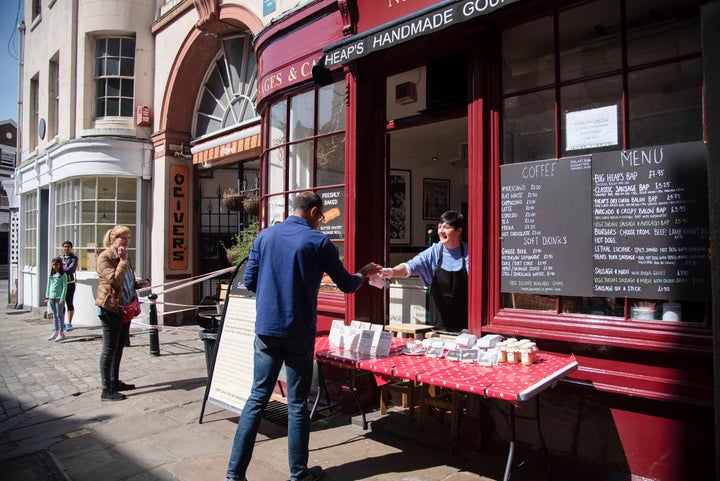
[0,0,23,122]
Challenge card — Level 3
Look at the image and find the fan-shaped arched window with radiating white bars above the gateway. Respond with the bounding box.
[194,35,259,138]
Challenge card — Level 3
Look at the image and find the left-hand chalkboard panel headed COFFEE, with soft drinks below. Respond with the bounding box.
[500,155,592,296]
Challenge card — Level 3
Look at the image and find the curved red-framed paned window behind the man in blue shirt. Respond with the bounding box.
[262,81,345,283]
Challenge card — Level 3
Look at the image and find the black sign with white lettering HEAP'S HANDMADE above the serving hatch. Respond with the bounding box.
[323,0,519,68]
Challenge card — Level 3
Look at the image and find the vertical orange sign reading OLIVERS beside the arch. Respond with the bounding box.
[168,164,190,271]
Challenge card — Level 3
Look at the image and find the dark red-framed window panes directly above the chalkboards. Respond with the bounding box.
[502,0,702,163]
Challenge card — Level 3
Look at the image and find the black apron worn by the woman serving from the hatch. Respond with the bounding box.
[430,244,468,331]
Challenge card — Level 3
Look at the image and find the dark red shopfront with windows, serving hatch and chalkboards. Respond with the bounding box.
[255,0,717,480]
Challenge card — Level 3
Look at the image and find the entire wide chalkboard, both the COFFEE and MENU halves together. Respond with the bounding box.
[500,142,710,301]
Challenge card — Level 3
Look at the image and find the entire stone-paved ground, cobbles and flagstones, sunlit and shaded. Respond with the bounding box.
[0,281,537,481]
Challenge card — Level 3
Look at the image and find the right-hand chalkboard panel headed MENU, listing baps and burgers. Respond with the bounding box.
[592,142,710,301]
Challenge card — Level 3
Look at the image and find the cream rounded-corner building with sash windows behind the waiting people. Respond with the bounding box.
[15,0,155,325]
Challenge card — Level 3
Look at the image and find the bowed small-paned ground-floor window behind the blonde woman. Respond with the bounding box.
[54,177,137,271]
